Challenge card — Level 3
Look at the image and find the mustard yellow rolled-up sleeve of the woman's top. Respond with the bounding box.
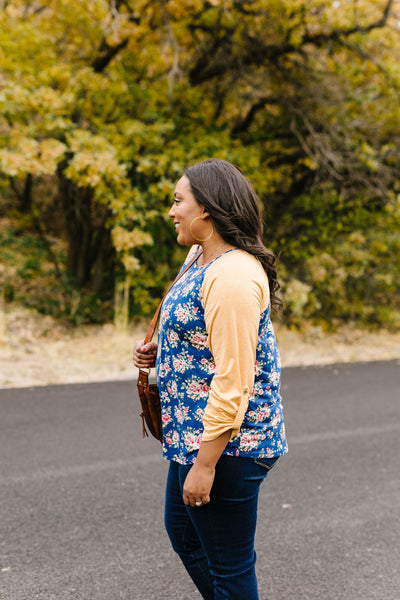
[202,250,269,441]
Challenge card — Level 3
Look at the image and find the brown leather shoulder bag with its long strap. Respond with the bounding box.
[137,251,202,443]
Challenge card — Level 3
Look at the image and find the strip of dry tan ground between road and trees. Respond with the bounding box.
[0,308,400,388]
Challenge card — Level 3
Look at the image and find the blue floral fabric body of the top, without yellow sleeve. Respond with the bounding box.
[157,253,287,464]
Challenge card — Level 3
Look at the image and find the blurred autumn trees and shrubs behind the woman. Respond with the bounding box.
[0,0,400,329]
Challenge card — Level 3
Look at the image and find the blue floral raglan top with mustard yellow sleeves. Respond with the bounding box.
[157,249,287,464]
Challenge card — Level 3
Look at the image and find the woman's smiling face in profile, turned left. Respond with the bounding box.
[168,175,211,246]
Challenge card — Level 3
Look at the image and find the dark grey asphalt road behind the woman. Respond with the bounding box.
[0,361,400,600]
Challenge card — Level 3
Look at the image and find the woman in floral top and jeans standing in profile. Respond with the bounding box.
[134,160,287,600]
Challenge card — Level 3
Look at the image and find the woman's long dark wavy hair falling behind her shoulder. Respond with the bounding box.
[184,159,282,312]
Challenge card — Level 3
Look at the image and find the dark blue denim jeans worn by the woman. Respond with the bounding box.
[165,455,277,600]
